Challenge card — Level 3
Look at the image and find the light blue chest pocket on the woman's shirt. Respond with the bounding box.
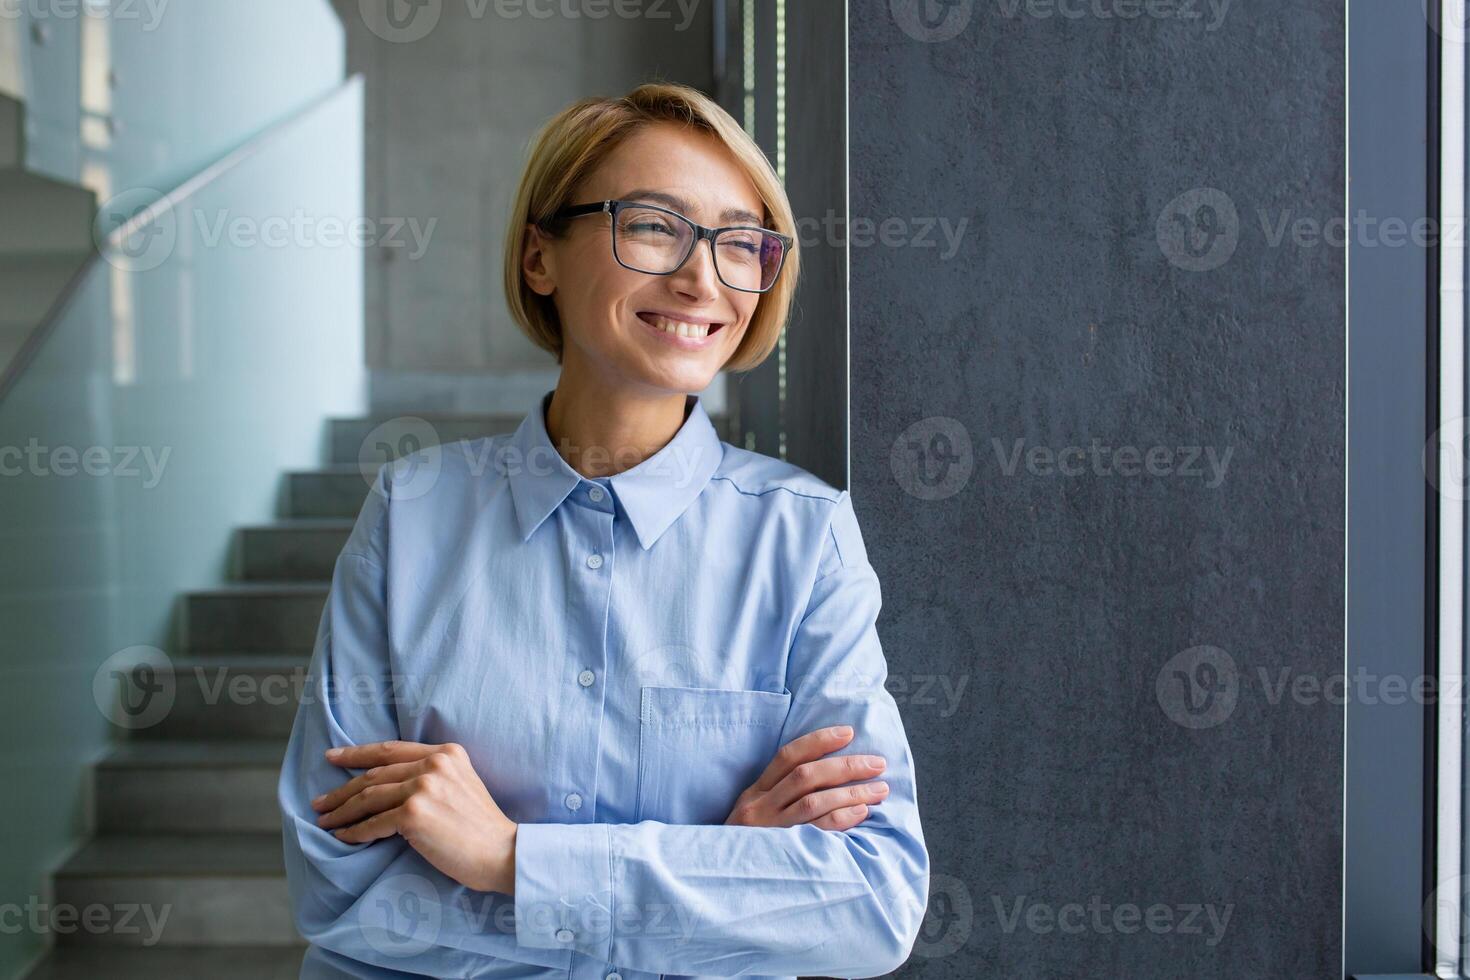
[634,688,791,824]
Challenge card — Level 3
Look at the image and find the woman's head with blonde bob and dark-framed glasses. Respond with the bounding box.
[504,85,801,391]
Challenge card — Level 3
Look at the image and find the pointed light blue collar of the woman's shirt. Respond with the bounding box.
[504,391,725,551]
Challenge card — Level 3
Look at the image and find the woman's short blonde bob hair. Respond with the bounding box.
[504,82,801,372]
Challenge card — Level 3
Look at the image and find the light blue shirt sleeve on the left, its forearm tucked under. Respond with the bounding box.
[278,464,566,977]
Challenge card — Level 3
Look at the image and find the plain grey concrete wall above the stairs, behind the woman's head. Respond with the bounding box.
[335,0,713,378]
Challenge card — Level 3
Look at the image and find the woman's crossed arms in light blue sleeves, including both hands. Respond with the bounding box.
[279,487,929,977]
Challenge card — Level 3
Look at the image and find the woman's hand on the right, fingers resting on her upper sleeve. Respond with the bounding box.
[725,724,888,830]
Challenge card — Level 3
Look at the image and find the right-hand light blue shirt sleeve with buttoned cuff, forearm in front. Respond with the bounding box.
[515,492,929,977]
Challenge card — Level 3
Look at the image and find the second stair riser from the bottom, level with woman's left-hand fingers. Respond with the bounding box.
[93,739,285,833]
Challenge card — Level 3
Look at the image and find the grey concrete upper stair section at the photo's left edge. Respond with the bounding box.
[0,96,97,376]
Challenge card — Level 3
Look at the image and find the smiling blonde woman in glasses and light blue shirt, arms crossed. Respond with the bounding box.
[279,85,929,980]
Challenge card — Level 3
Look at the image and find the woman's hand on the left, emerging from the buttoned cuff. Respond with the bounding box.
[312,742,516,895]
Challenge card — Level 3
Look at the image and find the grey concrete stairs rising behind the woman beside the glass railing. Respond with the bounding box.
[28,414,728,980]
